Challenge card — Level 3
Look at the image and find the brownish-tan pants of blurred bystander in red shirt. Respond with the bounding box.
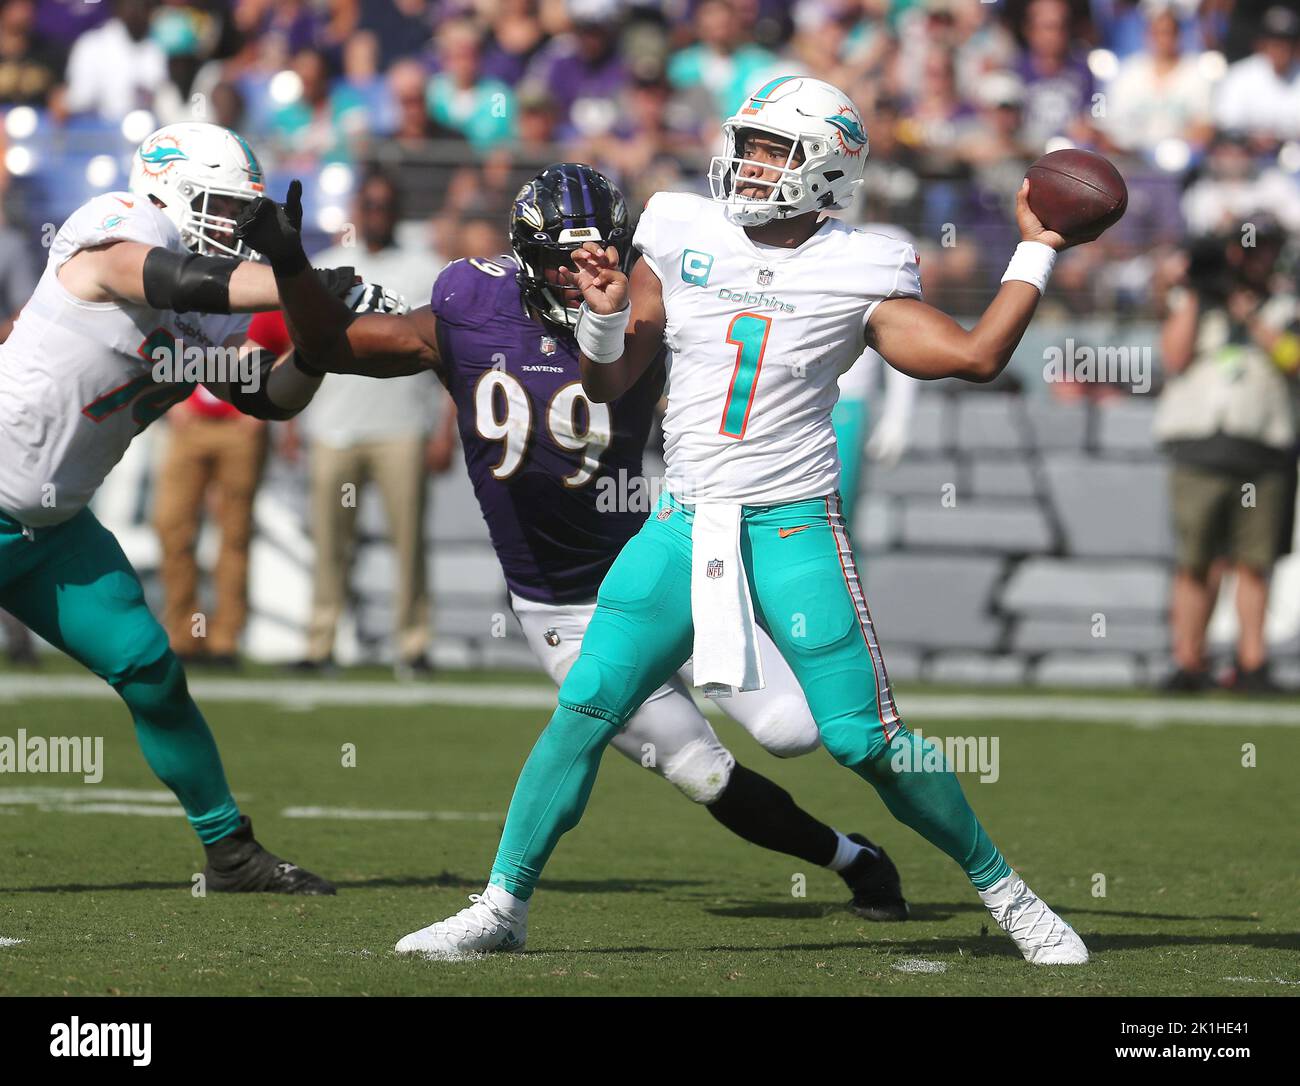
[153,415,267,656]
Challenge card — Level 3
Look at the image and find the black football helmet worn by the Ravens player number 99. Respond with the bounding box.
[510,163,632,332]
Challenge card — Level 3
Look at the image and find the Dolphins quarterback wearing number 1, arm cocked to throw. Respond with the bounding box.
[384,75,1107,965]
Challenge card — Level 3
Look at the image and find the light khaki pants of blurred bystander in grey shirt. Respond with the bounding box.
[307,436,429,661]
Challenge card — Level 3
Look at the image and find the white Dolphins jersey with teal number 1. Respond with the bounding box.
[633,192,920,506]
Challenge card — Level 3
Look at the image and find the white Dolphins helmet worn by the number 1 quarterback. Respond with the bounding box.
[709,75,867,226]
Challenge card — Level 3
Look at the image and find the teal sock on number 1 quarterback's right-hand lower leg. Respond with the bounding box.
[853,727,1011,890]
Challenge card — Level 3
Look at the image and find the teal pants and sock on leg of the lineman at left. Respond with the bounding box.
[0,509,239,844]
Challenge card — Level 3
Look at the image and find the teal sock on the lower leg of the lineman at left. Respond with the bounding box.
[113,652,239,844]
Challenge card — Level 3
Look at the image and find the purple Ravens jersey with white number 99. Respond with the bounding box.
[429,256,663,603]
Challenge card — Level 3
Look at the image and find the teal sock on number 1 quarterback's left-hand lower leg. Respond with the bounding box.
[491,705,618,901]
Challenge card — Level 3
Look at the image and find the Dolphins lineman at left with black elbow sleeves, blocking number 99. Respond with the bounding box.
[0,124,366,894]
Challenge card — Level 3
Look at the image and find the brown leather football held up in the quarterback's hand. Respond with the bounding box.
[1026,147,1128,238]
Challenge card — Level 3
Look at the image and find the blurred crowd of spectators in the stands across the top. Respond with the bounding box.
[0,0,1300,311]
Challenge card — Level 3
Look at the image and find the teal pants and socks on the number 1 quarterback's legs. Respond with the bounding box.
[491,496,1010,899]
